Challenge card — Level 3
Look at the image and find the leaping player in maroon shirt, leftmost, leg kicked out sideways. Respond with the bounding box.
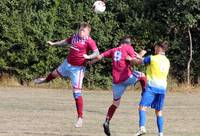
[35,23,99,127]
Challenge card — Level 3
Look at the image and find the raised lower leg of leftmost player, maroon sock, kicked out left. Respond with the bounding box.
[34,69,60,84]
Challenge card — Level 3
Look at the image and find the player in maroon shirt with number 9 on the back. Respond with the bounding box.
[90,36,146,136]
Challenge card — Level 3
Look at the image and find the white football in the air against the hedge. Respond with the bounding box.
[93,0,106,13]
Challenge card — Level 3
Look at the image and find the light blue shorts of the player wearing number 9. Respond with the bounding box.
[112,71,144,100]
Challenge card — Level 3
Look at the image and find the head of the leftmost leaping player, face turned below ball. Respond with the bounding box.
[78,22,91,38]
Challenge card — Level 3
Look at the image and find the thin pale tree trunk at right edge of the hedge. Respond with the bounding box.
[187,27,192,85]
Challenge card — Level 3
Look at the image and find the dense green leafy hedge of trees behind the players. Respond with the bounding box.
[0,0,200,88]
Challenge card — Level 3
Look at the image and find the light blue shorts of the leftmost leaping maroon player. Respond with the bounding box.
[57,59,85,91]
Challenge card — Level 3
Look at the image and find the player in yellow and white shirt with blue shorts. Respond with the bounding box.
[129,41,170,136]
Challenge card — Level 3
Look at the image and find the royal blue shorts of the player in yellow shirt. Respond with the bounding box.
[139,87,165,111]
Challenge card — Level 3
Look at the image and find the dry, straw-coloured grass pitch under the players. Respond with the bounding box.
[0,87,200,136]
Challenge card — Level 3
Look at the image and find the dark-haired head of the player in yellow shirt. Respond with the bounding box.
[155,41,169,54]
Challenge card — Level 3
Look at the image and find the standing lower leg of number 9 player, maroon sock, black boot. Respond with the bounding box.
[103,99,120,136]
